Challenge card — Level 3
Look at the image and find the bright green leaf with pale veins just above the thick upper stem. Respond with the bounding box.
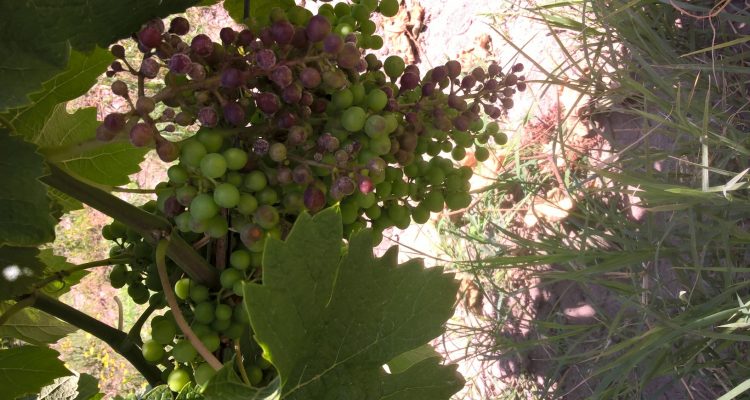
[33,104,148,185]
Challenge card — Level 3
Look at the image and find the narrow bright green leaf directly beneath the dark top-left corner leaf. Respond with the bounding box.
[3,48,114,139]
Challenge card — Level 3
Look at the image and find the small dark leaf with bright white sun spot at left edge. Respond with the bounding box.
[0,246,46,301]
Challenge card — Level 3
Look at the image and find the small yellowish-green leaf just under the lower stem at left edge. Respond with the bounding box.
[0,302,78,346]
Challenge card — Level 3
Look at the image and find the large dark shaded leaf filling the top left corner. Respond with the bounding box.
[0,0,198,112]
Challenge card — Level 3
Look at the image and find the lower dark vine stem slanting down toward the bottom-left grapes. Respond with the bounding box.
[24,292,161,386]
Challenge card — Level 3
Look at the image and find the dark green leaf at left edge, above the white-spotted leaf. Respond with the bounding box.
[0,129,56,246]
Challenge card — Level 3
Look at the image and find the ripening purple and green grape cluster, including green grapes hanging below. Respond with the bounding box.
[97,0,526,387]
